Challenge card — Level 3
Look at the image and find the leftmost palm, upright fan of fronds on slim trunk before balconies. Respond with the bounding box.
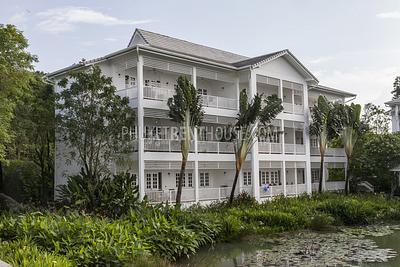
[167,76,204,206]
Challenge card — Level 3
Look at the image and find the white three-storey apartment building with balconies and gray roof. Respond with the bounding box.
[49,29,355,203]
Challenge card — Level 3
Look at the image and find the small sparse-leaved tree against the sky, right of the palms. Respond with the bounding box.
[361,103,390,134]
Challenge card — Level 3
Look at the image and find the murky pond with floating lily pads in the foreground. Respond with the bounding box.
[178,226,400,267]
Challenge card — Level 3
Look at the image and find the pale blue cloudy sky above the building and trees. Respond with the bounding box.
[0,0,400,105]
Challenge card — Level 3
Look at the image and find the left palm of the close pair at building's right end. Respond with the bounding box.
[310,96,336,192]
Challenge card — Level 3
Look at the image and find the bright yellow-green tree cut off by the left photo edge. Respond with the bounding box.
[0,24,37,188]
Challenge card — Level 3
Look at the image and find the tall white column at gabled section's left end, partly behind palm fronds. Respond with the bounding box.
[249,70,260,201]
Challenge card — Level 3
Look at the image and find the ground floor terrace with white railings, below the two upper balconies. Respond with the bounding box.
[136,161,344,204]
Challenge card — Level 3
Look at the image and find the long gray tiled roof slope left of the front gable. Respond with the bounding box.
[137,29,248,64]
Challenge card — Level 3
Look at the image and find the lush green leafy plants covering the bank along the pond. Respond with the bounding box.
[0,194,400,266]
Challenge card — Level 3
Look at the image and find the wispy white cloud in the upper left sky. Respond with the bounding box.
[37,7,152,33]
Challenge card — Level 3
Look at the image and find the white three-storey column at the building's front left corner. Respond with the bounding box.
[137,55,145,198]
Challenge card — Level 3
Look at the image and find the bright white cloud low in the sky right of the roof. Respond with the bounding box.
[314,66,400,105]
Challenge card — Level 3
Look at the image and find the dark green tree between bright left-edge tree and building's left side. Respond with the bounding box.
[7,73,55,204]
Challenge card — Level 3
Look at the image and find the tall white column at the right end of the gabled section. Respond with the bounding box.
[303,83,312,195]
